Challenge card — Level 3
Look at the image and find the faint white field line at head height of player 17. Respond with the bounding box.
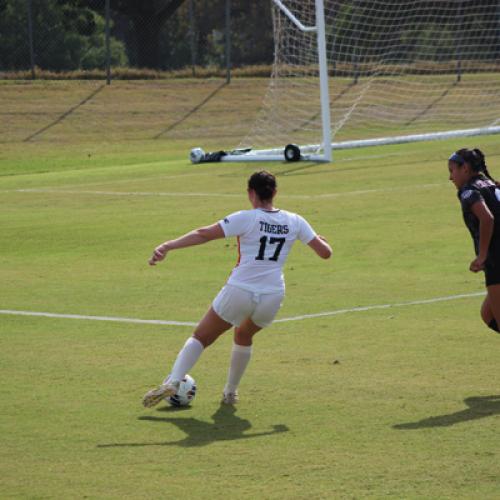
[6,182,447,200]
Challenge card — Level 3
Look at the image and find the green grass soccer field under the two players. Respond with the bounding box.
[0,82,500,499]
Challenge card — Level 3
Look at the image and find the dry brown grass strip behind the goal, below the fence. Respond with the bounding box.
[0,73,500,149]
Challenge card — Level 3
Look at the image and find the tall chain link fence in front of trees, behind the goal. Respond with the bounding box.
[0,0,500,81]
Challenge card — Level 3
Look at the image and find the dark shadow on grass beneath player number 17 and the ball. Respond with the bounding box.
[97,404,289,448]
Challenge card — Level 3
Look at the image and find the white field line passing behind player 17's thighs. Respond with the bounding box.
[0,292,485,327]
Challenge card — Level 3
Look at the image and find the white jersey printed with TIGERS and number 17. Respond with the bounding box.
[219,208,316,293]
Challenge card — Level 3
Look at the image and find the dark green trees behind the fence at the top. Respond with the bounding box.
[0,0,500,71]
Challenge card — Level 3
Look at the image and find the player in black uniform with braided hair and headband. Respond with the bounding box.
[448,149,500,333]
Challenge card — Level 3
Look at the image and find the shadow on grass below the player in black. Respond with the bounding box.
[393,395,500,430]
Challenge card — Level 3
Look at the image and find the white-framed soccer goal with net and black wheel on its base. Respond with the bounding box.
[191,0,500,163]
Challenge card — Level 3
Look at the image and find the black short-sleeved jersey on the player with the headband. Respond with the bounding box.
[458,175,500,260]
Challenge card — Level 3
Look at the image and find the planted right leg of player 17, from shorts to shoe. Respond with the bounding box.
[222,294,283,404]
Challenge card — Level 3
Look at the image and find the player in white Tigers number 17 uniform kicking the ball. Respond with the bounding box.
[143,171,332,408]
